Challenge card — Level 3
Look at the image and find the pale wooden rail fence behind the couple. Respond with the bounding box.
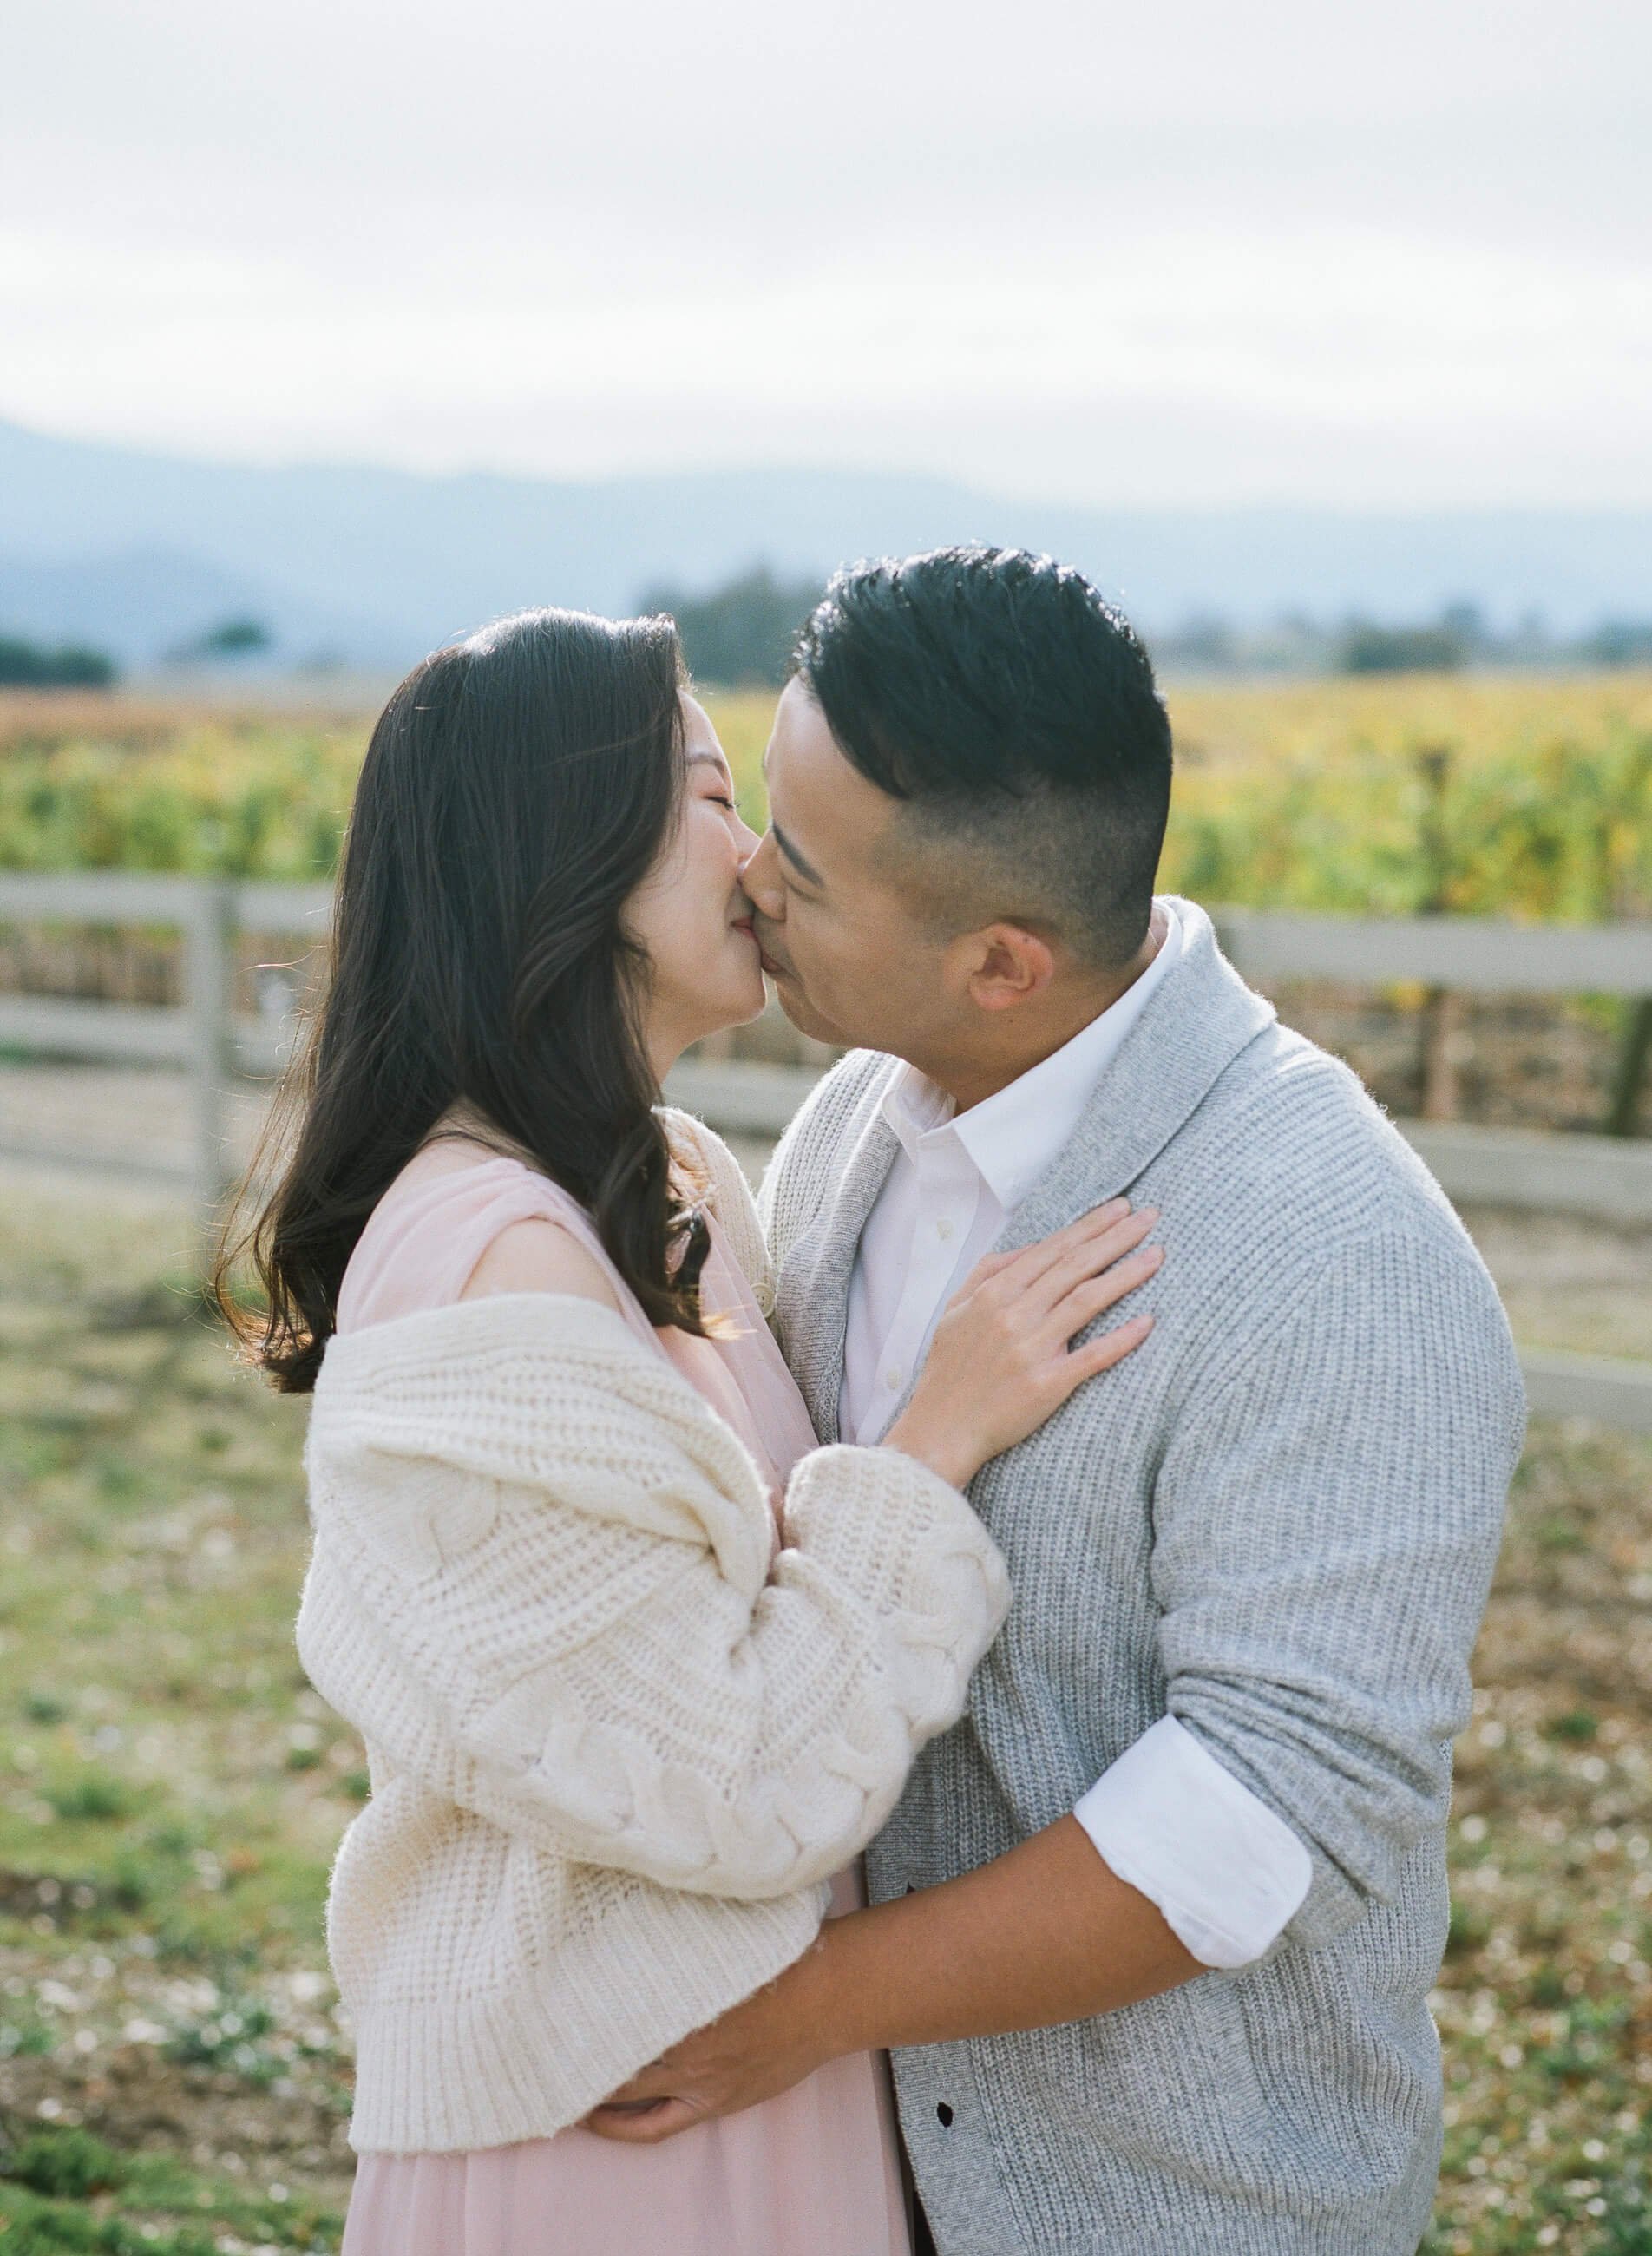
[0,871,1652,1430]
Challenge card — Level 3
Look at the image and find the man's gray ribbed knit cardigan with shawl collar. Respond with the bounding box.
[763,900,1525,2256]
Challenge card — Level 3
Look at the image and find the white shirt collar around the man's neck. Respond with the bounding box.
[882,902,1183,1214]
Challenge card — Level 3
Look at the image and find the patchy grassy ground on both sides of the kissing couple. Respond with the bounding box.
[0,1177,1652,2256]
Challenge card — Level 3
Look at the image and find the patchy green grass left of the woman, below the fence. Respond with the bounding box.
[0,1193,351,2256]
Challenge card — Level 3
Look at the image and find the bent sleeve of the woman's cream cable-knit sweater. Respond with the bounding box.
[298,1300,1009,1898]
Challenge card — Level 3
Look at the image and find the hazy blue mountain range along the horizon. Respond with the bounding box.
[0,422,1652,670]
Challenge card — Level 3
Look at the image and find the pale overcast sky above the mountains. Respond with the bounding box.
[0,0,1652,508]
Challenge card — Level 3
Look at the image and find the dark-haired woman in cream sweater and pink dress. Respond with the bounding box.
[226,612,1156,2256]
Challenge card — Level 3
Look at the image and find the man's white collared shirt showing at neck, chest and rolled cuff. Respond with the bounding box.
[840,902,1311,1967]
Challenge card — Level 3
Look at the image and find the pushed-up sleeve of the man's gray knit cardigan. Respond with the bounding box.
[1151,1234,1525,1944]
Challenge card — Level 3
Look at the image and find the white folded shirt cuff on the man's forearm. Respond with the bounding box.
[1074,1715,1314,1967]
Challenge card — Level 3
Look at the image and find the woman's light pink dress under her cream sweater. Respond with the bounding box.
[338,1144,912,2256]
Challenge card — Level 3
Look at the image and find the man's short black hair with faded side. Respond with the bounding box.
[792,546,1171,967]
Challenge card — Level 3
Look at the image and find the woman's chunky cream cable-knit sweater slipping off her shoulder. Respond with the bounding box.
[298,1139,1009,2152]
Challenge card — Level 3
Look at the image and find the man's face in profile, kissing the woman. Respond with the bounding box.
[740,677,964,1056]
